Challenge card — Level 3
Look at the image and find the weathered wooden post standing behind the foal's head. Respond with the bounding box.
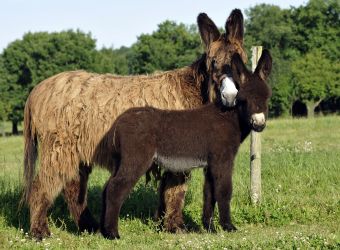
[250,46,262,204]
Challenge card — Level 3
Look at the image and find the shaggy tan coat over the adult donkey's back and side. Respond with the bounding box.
[26,69,201,162]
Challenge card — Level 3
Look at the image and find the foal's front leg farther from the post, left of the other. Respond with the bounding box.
[202,168,216,231]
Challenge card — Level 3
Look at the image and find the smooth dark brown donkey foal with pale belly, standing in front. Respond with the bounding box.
[101,50,272,239]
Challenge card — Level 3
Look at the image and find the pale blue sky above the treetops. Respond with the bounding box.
[0,0,307,52]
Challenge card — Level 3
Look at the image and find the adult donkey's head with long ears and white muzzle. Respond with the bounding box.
[197,9,247,107]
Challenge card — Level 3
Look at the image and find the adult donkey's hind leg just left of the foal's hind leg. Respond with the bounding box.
[63,163,99,232]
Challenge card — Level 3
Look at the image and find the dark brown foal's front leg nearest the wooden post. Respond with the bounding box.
[211,162,237,232]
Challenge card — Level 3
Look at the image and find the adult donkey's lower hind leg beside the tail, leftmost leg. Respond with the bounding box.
[29,173,62,240]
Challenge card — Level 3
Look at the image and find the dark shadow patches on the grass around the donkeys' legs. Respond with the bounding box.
[0,180,199,234]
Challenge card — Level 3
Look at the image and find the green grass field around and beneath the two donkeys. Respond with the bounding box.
[0,116,340,249]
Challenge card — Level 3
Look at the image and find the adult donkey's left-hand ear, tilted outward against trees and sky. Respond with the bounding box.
[197,13,221,48]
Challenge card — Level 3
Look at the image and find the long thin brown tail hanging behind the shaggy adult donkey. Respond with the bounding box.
[20,99,38,205]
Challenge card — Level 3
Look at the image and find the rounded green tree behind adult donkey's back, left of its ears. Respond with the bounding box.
[129,21,202,74]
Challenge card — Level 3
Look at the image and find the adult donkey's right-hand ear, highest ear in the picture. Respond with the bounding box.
[225,9,243,44]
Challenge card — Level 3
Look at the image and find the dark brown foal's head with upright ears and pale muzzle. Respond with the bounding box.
[231,50,272,132]
